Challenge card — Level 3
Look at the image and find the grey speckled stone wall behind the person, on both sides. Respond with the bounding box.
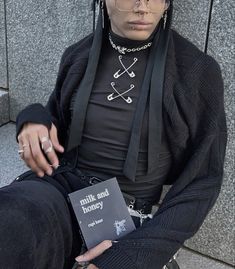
[0,0,235,264]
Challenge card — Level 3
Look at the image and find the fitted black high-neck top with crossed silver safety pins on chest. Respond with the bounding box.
[78,30,171,202]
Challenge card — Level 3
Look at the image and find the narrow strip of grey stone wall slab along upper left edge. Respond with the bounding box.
[0,0,7,88]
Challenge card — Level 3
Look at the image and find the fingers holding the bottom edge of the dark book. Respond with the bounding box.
[76,240,112,262]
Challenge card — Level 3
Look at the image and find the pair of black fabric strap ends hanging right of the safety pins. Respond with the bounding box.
[123,27,169,181]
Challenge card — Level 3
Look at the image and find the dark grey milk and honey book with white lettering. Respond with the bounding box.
[69,178,135,249]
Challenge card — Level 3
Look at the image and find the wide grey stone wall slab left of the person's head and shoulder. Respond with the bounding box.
[6,0,92,120]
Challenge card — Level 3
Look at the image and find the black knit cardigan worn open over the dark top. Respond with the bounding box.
[17,30,227,269]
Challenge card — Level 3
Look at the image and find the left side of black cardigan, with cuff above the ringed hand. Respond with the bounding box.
[16,34,93,145]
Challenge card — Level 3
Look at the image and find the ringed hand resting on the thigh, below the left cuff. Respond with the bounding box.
[18,123,64,177]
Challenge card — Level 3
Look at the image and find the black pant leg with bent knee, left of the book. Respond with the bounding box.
[0,177,81,269]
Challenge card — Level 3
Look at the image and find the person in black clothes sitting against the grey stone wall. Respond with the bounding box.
[0,0,227,269]
